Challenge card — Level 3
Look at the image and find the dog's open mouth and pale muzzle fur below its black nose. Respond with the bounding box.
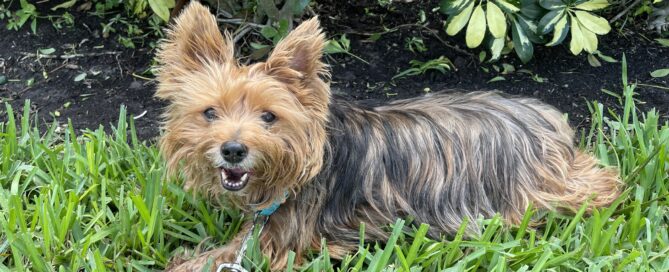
[206,147,257,192]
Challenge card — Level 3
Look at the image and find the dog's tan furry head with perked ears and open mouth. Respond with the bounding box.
[156,1,330,205]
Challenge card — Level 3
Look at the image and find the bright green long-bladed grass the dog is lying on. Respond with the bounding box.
[0,60,669,271]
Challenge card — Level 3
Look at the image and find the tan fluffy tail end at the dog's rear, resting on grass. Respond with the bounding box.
[549,151,622,211]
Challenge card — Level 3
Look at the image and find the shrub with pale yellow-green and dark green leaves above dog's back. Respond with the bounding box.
[440,0,611,62]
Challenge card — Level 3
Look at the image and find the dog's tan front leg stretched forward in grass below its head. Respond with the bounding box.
[165,224,251,272]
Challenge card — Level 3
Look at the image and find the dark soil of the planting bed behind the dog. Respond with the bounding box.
[0,0,669,139]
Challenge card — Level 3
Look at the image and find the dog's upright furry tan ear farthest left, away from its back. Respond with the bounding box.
[156,1,234,98]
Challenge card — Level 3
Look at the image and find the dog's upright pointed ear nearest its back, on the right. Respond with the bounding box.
[266,17,325,81]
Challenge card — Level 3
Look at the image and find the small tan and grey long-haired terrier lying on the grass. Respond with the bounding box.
[156,1,621,271]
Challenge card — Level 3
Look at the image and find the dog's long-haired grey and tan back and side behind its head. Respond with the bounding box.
[319,92,619,240]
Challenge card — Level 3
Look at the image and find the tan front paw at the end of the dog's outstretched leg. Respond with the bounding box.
[165,247,236,272]
